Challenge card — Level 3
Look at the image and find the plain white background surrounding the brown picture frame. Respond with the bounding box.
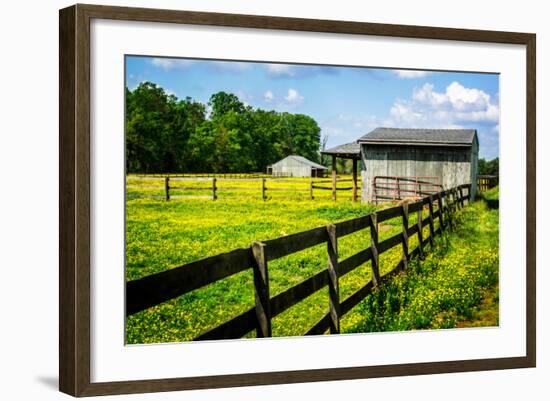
[0,0,550,401]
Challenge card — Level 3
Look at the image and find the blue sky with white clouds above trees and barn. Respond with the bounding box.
[126,56,499,159]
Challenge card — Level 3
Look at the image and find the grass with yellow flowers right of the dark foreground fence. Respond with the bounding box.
[348,188,499,333]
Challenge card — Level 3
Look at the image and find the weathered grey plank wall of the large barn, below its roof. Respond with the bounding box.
[361,144,477,201]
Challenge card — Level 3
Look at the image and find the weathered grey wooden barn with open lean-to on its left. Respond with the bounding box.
[322,128,479,202]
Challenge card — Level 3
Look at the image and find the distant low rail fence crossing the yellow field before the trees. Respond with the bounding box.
[127,174,362,201]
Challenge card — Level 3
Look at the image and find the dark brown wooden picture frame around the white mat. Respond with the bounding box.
[59,4,536,396]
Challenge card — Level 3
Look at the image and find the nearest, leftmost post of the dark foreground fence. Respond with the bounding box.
[252,241,271,338]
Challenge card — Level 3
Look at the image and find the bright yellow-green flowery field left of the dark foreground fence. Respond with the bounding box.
[126,177,498,343]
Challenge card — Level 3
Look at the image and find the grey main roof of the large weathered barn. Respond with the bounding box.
[357,127,476,146]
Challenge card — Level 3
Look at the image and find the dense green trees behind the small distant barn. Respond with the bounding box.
[126,82,321,173]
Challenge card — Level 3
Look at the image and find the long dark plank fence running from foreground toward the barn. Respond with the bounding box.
[126,184,470,340]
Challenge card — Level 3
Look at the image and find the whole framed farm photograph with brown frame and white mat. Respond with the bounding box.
[59,5,536,396]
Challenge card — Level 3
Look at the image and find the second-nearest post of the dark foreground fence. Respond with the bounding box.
[327,224,340,334]
